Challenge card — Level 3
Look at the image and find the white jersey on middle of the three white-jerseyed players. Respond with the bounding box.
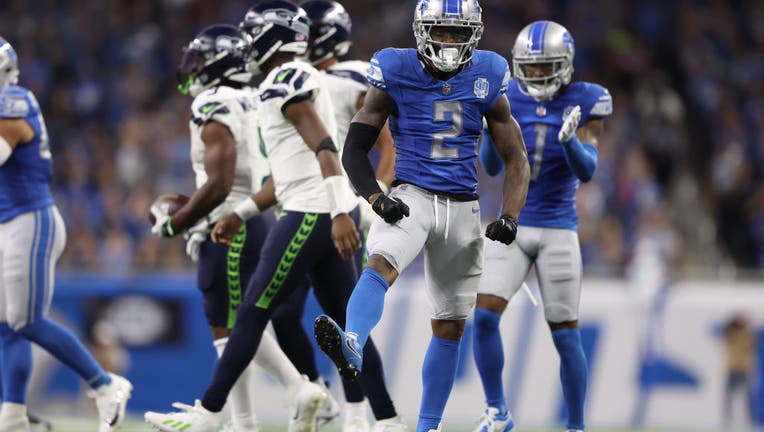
[259,61,337,213]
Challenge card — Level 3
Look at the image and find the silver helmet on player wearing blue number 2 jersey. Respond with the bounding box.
[413,0,483,72]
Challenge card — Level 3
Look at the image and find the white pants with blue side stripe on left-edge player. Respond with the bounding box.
[0,206,66,330]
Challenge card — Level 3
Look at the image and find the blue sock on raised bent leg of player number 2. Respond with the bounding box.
[345,268,390,347]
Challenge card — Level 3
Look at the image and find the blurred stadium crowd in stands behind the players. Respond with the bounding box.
[0,0,764,276]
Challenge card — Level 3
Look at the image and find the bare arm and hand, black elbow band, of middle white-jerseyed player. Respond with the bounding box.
[282,99,361,260]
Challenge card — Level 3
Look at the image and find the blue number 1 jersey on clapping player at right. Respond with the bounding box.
[481,80,613,230]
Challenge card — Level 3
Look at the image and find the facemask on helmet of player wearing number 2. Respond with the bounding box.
[414,19,483,73]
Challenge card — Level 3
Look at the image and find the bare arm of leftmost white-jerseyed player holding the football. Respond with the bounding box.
[171,121,236,232]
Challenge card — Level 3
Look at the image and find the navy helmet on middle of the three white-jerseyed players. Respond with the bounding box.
[239,0,310,74]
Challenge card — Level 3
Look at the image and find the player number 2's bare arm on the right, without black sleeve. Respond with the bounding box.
[486,96,531,243]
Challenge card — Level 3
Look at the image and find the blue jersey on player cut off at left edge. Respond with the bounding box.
[0,85,53,222]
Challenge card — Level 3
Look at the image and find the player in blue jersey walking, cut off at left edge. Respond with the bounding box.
[0,38,132,432]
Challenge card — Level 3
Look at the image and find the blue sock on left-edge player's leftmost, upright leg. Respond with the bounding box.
[0,323,32,405]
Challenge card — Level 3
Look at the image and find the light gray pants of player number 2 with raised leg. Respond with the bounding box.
[367,184,483,320]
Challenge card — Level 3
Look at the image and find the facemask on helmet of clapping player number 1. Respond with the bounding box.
[512,57,573,101]
